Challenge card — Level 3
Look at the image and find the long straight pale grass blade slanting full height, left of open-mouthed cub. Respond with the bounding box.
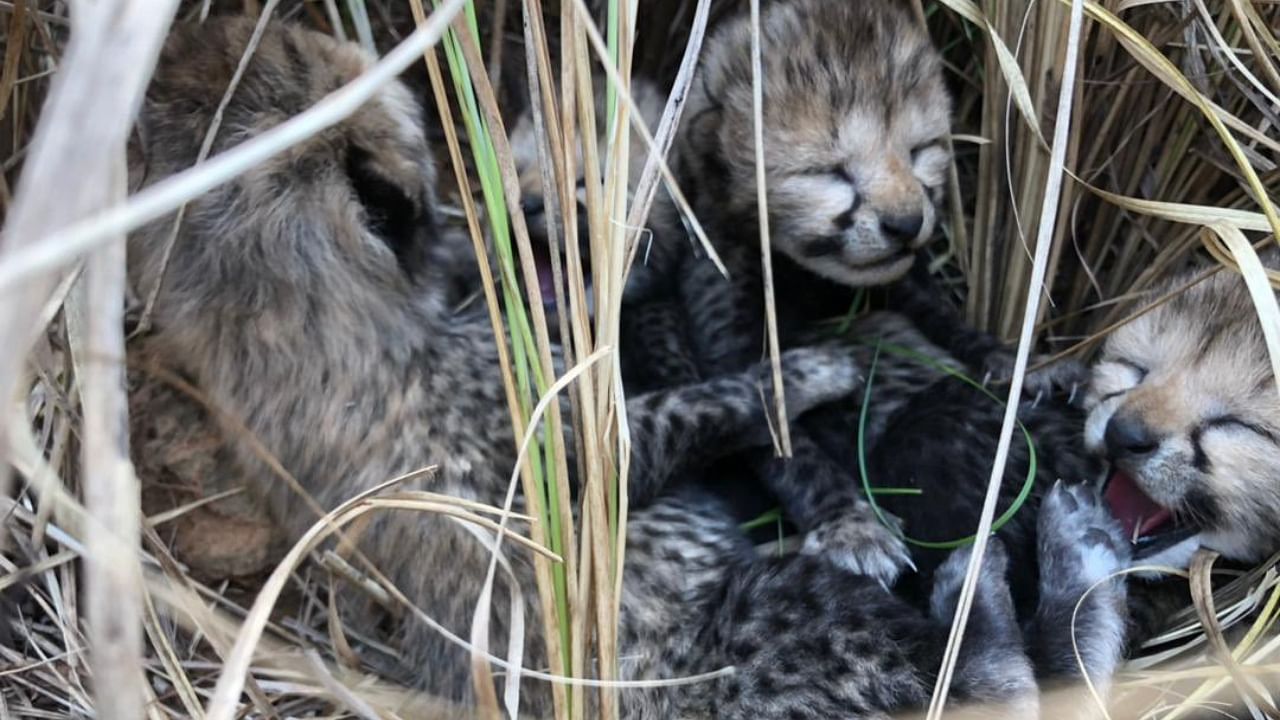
[928,0,1084,720]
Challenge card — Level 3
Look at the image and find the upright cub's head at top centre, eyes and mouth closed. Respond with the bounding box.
[678,0,951,286]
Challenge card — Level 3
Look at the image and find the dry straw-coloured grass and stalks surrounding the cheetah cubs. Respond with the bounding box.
[0,0,1280,719]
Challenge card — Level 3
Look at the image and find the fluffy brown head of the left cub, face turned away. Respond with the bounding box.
[129,18,438,345]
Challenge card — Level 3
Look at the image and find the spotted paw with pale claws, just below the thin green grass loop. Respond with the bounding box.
[800,507,915,587]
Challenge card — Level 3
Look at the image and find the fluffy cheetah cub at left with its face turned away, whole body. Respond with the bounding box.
[129,19,1100,720]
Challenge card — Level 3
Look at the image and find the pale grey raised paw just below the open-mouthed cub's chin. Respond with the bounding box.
[1038,480,1129,593]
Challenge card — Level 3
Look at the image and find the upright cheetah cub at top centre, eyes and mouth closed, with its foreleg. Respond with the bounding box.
[623,0,951,582]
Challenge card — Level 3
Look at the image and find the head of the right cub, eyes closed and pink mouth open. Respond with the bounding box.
[1085,263,1280,566]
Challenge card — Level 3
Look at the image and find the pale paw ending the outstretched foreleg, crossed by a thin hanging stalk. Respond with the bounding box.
[760,345,864,418]
